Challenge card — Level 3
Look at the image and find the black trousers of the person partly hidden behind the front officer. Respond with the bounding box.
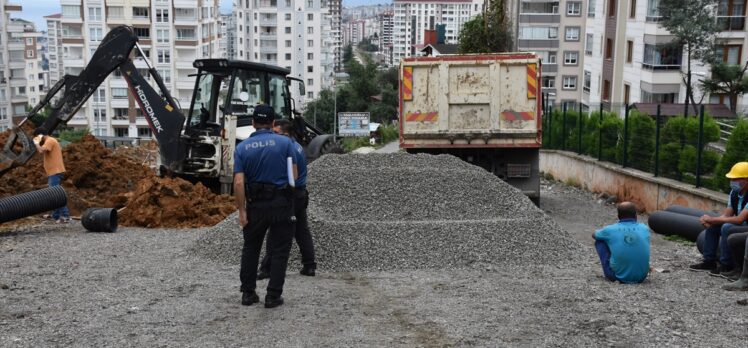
[260,189,317,272]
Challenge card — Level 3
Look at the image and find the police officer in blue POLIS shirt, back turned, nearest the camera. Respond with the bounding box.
[234,105,296,308]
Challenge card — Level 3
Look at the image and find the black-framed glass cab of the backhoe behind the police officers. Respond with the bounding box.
[185,59,292,142]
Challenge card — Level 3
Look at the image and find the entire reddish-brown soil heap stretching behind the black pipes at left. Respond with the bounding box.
[0,132,236,227]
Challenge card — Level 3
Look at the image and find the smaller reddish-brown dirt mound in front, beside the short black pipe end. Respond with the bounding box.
[119,177,236,228]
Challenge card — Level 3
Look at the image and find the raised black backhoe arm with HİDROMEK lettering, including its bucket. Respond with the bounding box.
[0,26,185,176]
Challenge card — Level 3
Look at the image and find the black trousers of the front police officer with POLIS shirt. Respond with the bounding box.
[239,200,295,296]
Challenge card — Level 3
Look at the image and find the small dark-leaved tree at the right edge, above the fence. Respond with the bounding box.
[701,62,748,111]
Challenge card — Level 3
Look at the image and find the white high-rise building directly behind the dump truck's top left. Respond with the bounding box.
[392,0,484,64]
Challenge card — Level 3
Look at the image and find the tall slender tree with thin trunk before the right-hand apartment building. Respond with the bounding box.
[658,0,719,116]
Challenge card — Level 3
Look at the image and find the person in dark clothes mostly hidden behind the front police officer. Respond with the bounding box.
[257,120,317,279]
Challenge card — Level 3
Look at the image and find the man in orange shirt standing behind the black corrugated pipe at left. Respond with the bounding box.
[34,127,70,223]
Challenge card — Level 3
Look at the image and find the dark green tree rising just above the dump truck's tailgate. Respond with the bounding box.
[458,0,514,53]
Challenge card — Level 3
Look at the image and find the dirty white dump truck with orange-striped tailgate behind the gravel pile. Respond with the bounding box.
[399,53,542,204]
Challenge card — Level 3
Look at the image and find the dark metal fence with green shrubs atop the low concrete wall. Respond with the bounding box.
[543,103,734,191]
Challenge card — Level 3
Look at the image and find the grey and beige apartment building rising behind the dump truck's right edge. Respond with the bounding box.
[510,0,588,107]
